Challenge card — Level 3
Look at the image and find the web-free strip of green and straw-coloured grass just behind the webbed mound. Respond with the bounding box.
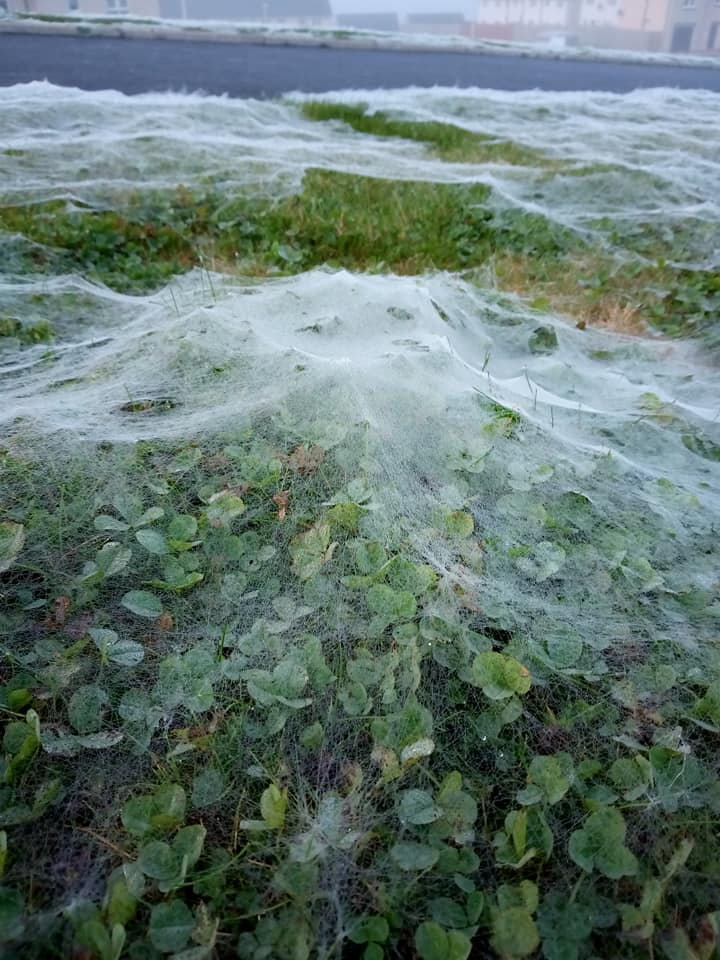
[0,170,720,336]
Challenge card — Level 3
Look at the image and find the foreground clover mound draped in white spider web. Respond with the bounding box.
[0,270,720,960]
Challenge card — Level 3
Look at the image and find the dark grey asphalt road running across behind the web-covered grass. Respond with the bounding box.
[0,33,720,97]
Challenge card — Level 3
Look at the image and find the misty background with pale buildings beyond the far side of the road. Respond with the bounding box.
[0,0,720,57]
